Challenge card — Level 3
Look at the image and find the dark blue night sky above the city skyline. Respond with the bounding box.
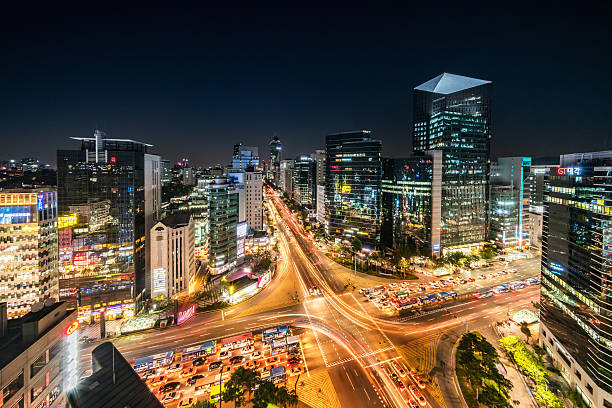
[0,5,612,166]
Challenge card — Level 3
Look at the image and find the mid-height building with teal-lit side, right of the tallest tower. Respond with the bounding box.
[489,157,531,249]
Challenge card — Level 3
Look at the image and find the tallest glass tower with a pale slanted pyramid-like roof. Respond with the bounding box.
[413,73,491,251]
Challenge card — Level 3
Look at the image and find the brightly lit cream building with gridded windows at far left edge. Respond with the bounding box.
[0,190,59,319]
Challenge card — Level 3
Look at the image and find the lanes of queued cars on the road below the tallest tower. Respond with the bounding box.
[359,268,539,315]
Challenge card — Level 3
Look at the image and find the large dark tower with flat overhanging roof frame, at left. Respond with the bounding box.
[57,131,161,316]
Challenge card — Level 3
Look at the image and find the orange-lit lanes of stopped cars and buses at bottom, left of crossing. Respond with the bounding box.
[133,326,304,408]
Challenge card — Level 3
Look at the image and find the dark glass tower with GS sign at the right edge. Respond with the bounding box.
[539,151,612,407]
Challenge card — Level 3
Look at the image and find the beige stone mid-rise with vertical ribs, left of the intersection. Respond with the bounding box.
[151,213,196,297]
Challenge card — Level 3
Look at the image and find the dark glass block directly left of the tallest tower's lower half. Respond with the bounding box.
[381,151,442,256]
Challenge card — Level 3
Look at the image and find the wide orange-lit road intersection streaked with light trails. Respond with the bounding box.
[81,192,538,407]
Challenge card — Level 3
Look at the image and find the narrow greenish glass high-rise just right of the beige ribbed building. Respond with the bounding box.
[208,178,239,274]
